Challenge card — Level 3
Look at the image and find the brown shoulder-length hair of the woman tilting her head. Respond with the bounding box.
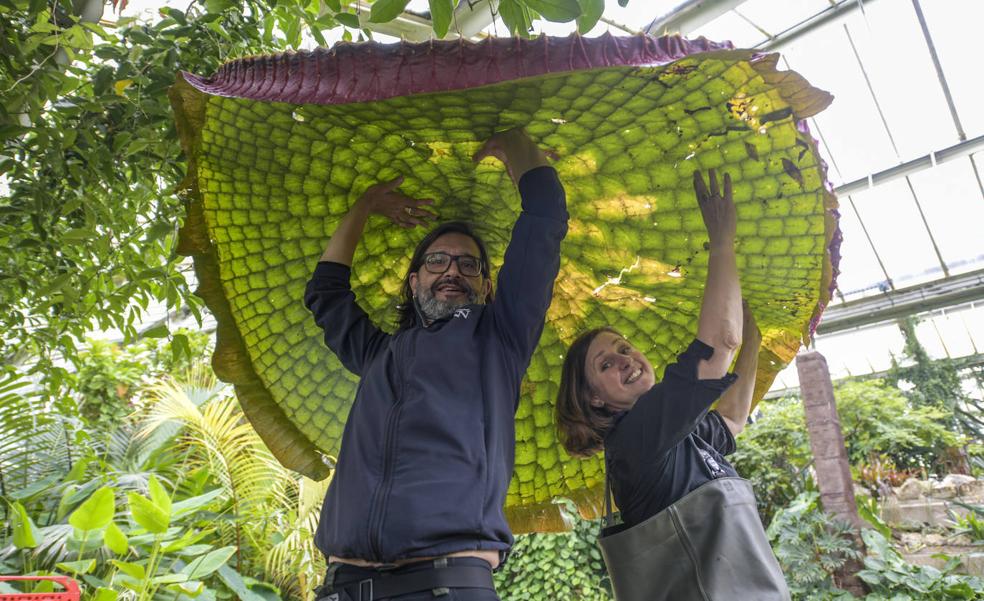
[554,327,621,457]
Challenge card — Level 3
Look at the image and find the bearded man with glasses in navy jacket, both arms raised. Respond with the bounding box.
[304,130,567,601]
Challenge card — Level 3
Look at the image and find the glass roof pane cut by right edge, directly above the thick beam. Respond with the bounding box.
[911,158,984,274]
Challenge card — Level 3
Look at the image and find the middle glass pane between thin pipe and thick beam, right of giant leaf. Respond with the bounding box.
[853,179,943,288]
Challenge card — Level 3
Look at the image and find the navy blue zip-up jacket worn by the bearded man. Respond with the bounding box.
[304,167,567,562]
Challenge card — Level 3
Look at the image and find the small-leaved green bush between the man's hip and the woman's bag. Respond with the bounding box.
[496,505,611,601]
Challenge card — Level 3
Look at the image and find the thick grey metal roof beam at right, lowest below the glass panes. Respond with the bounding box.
[817,269,984,336]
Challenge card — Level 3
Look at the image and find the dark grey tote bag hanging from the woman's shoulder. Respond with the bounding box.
[598,477,790,601]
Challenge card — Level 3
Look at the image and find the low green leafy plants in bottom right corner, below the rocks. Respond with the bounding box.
[858,530,984,601]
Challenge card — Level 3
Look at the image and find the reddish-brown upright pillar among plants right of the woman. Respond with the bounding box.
[796,351,865,596]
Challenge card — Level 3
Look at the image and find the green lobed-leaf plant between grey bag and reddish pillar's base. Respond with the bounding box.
[768,492,861,600]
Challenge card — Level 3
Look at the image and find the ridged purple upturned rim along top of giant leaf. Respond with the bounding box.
[177,33,734,104]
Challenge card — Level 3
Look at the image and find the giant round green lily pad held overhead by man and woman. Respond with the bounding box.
[171,37,839,532]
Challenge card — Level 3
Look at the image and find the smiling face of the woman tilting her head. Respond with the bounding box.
[584,332,656,411]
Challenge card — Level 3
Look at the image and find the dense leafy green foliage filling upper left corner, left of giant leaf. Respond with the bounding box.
[0,0,603,379]
